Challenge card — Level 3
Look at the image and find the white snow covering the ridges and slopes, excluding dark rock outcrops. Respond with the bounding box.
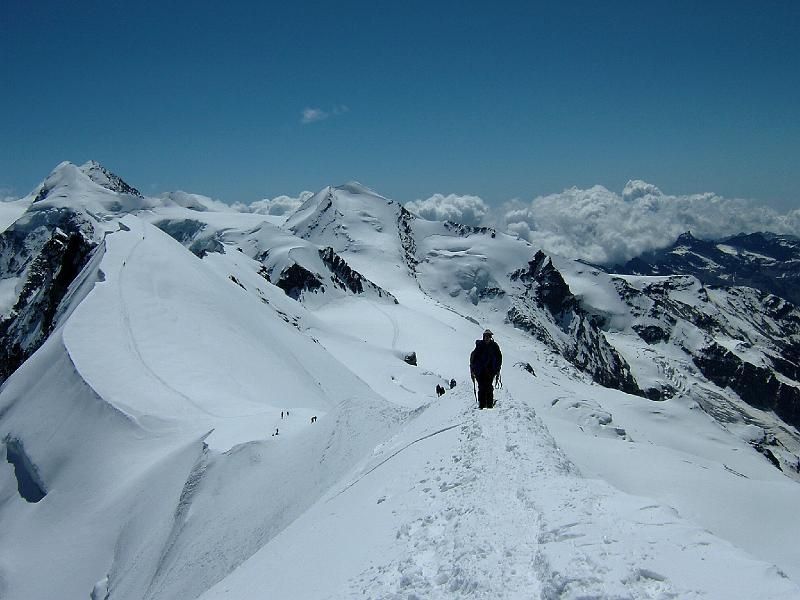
[0,167,800,600]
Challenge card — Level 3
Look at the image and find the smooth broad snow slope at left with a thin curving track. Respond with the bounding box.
[64,218,367,451]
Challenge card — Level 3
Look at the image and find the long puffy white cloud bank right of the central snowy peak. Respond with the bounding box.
[406,180,800,264]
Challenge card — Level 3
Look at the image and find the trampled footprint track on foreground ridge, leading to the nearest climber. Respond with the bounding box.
[350,392,541,600]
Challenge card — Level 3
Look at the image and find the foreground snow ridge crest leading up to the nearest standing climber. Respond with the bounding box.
[201,390,800,600]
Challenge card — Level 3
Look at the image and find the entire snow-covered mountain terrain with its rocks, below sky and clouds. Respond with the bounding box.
[0,163,800,599]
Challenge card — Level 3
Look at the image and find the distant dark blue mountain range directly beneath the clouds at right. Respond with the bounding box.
[609,232,800,304]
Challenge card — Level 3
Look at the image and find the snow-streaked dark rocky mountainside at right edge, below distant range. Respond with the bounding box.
[614,262,800,426]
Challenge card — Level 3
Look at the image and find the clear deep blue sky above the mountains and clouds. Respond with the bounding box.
[0,0,800,210]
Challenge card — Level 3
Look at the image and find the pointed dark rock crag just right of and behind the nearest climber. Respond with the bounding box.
[507,251,644,396]
